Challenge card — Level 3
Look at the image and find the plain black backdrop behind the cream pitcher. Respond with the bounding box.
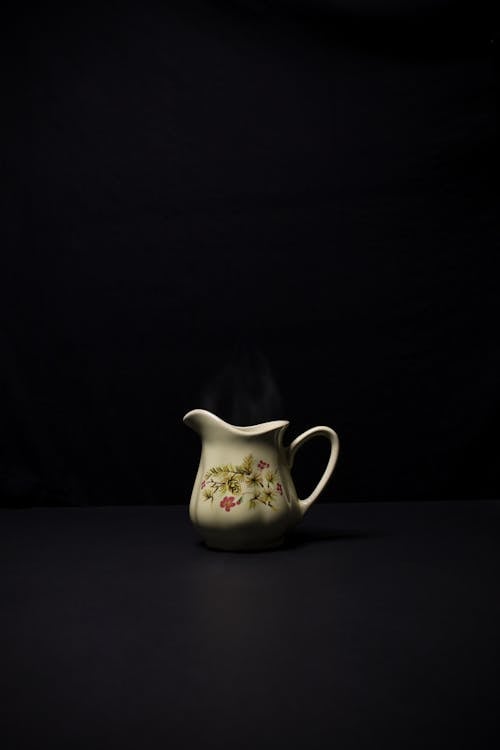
[0,0,500,506]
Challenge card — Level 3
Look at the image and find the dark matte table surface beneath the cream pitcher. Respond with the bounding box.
[0,501,500,750]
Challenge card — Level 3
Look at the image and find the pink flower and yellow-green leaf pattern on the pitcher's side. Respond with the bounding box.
[201,454,283,513]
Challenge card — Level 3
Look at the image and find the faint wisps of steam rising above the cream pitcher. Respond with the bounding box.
[201,345,283,425]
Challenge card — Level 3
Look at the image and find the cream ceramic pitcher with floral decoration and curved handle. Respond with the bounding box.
[184,409,339,550]
